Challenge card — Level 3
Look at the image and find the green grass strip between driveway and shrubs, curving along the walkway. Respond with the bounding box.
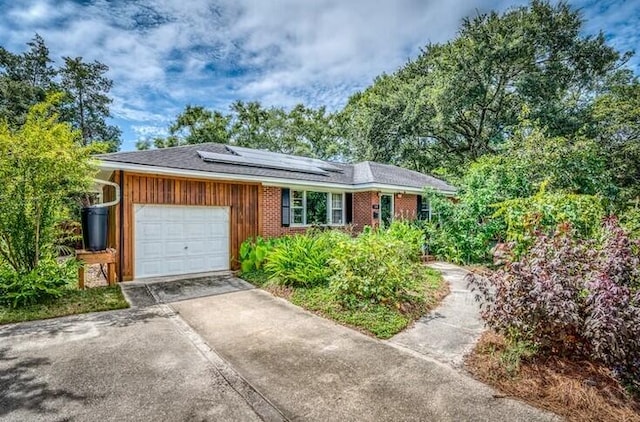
[242,268,449,339]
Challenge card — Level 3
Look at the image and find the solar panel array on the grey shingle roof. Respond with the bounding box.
[198,146,342,176]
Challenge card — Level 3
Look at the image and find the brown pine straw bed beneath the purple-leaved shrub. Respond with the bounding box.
[465,332,640,422]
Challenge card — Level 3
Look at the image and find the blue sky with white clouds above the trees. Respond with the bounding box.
[0,0,640,149]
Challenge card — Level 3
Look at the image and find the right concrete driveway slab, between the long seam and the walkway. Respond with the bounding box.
[171,289,559,422]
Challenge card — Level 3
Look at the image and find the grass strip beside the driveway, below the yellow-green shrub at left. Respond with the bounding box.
[0,286,129,324]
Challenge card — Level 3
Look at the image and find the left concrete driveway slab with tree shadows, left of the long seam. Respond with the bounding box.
[0,306,277,422]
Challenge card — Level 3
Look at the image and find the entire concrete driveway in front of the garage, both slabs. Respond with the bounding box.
[0,280,559,422]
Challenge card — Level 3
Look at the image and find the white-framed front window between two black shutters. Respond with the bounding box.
[291,190,344,226]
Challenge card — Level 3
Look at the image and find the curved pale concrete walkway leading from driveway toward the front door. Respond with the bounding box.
[389,262,484,367]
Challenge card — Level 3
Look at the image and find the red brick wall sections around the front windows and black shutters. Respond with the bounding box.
[259,186,417,237]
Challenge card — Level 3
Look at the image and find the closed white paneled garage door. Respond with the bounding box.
[134,205,229,278]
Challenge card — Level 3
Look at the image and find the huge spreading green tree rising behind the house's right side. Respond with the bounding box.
[343,0,627,172]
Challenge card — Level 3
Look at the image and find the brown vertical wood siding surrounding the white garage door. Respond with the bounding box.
[109,172,261,280]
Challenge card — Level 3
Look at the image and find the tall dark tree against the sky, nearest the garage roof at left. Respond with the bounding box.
[60,57,121,151]
